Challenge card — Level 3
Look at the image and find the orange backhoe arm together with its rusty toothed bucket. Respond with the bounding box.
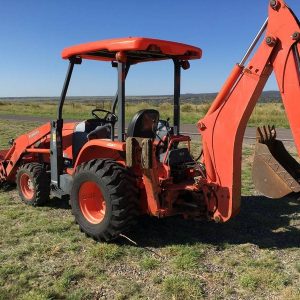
[198,0,300,222]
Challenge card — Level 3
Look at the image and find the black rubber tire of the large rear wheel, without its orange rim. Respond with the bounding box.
[70,159,139,241]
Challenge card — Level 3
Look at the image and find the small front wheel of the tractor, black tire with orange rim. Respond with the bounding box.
[16,163,50,206]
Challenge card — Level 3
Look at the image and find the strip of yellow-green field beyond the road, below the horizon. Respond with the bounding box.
[0,100,289,128]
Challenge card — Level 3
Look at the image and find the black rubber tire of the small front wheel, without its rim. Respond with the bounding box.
[16,162,50,206]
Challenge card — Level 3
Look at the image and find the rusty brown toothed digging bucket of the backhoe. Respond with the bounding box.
[252,126,300,198]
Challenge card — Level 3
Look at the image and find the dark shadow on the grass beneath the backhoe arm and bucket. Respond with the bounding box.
[130,196,300,250]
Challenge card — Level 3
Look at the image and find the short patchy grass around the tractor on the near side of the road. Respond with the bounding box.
[0,120,300,300]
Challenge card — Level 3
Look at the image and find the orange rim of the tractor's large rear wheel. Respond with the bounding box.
[79,181,106,224]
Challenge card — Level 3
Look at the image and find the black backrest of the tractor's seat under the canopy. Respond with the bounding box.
[127,109,159,138]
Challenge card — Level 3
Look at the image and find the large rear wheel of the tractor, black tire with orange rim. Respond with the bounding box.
[70,159,138,241]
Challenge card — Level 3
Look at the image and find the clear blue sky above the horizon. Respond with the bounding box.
[0,0,300,97]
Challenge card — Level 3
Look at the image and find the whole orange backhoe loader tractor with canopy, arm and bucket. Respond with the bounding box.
[0,0,300,241]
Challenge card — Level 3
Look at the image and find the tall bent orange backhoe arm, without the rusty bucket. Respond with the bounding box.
[198,0,300,221]
